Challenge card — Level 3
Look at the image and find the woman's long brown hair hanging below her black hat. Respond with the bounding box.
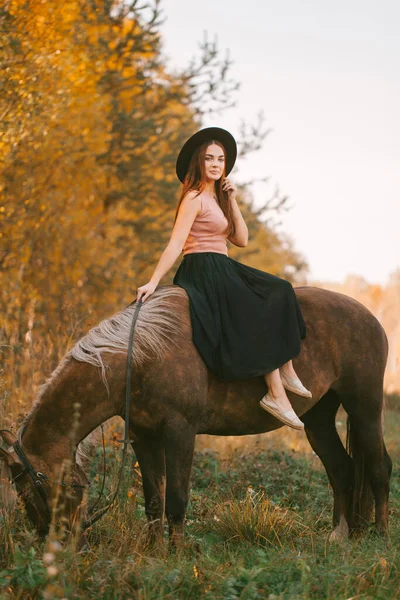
[174,140,236,236]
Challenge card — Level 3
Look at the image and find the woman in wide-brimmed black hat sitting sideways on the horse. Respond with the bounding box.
[137,127,311,429]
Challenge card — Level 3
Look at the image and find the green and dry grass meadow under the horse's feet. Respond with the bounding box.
[0,410,400,600]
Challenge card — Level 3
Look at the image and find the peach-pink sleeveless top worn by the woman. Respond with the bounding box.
[183,192,228,256]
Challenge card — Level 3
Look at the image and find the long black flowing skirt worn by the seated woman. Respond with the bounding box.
[173,252,306,381]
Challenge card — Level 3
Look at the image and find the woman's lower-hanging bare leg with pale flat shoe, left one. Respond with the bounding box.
[260,369,304,429]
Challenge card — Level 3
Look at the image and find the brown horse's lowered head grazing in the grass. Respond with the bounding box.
[0,430,88,536]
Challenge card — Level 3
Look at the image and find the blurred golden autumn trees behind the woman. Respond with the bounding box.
[0,0,308,360]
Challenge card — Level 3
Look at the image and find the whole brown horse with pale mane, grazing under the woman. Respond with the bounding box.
[0,286,391,542]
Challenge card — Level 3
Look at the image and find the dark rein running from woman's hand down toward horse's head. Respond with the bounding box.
[83,298,142,530]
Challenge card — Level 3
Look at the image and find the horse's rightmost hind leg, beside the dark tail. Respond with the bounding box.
[341,392,392,535]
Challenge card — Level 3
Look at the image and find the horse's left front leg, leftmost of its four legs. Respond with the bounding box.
[132,432,165,543]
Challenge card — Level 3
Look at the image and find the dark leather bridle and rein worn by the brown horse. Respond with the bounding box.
[6,299,142,529]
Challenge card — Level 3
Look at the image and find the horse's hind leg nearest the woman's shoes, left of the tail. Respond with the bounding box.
[302,390,354,541]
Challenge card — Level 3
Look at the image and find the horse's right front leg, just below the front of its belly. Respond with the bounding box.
[163,421,196,548]
